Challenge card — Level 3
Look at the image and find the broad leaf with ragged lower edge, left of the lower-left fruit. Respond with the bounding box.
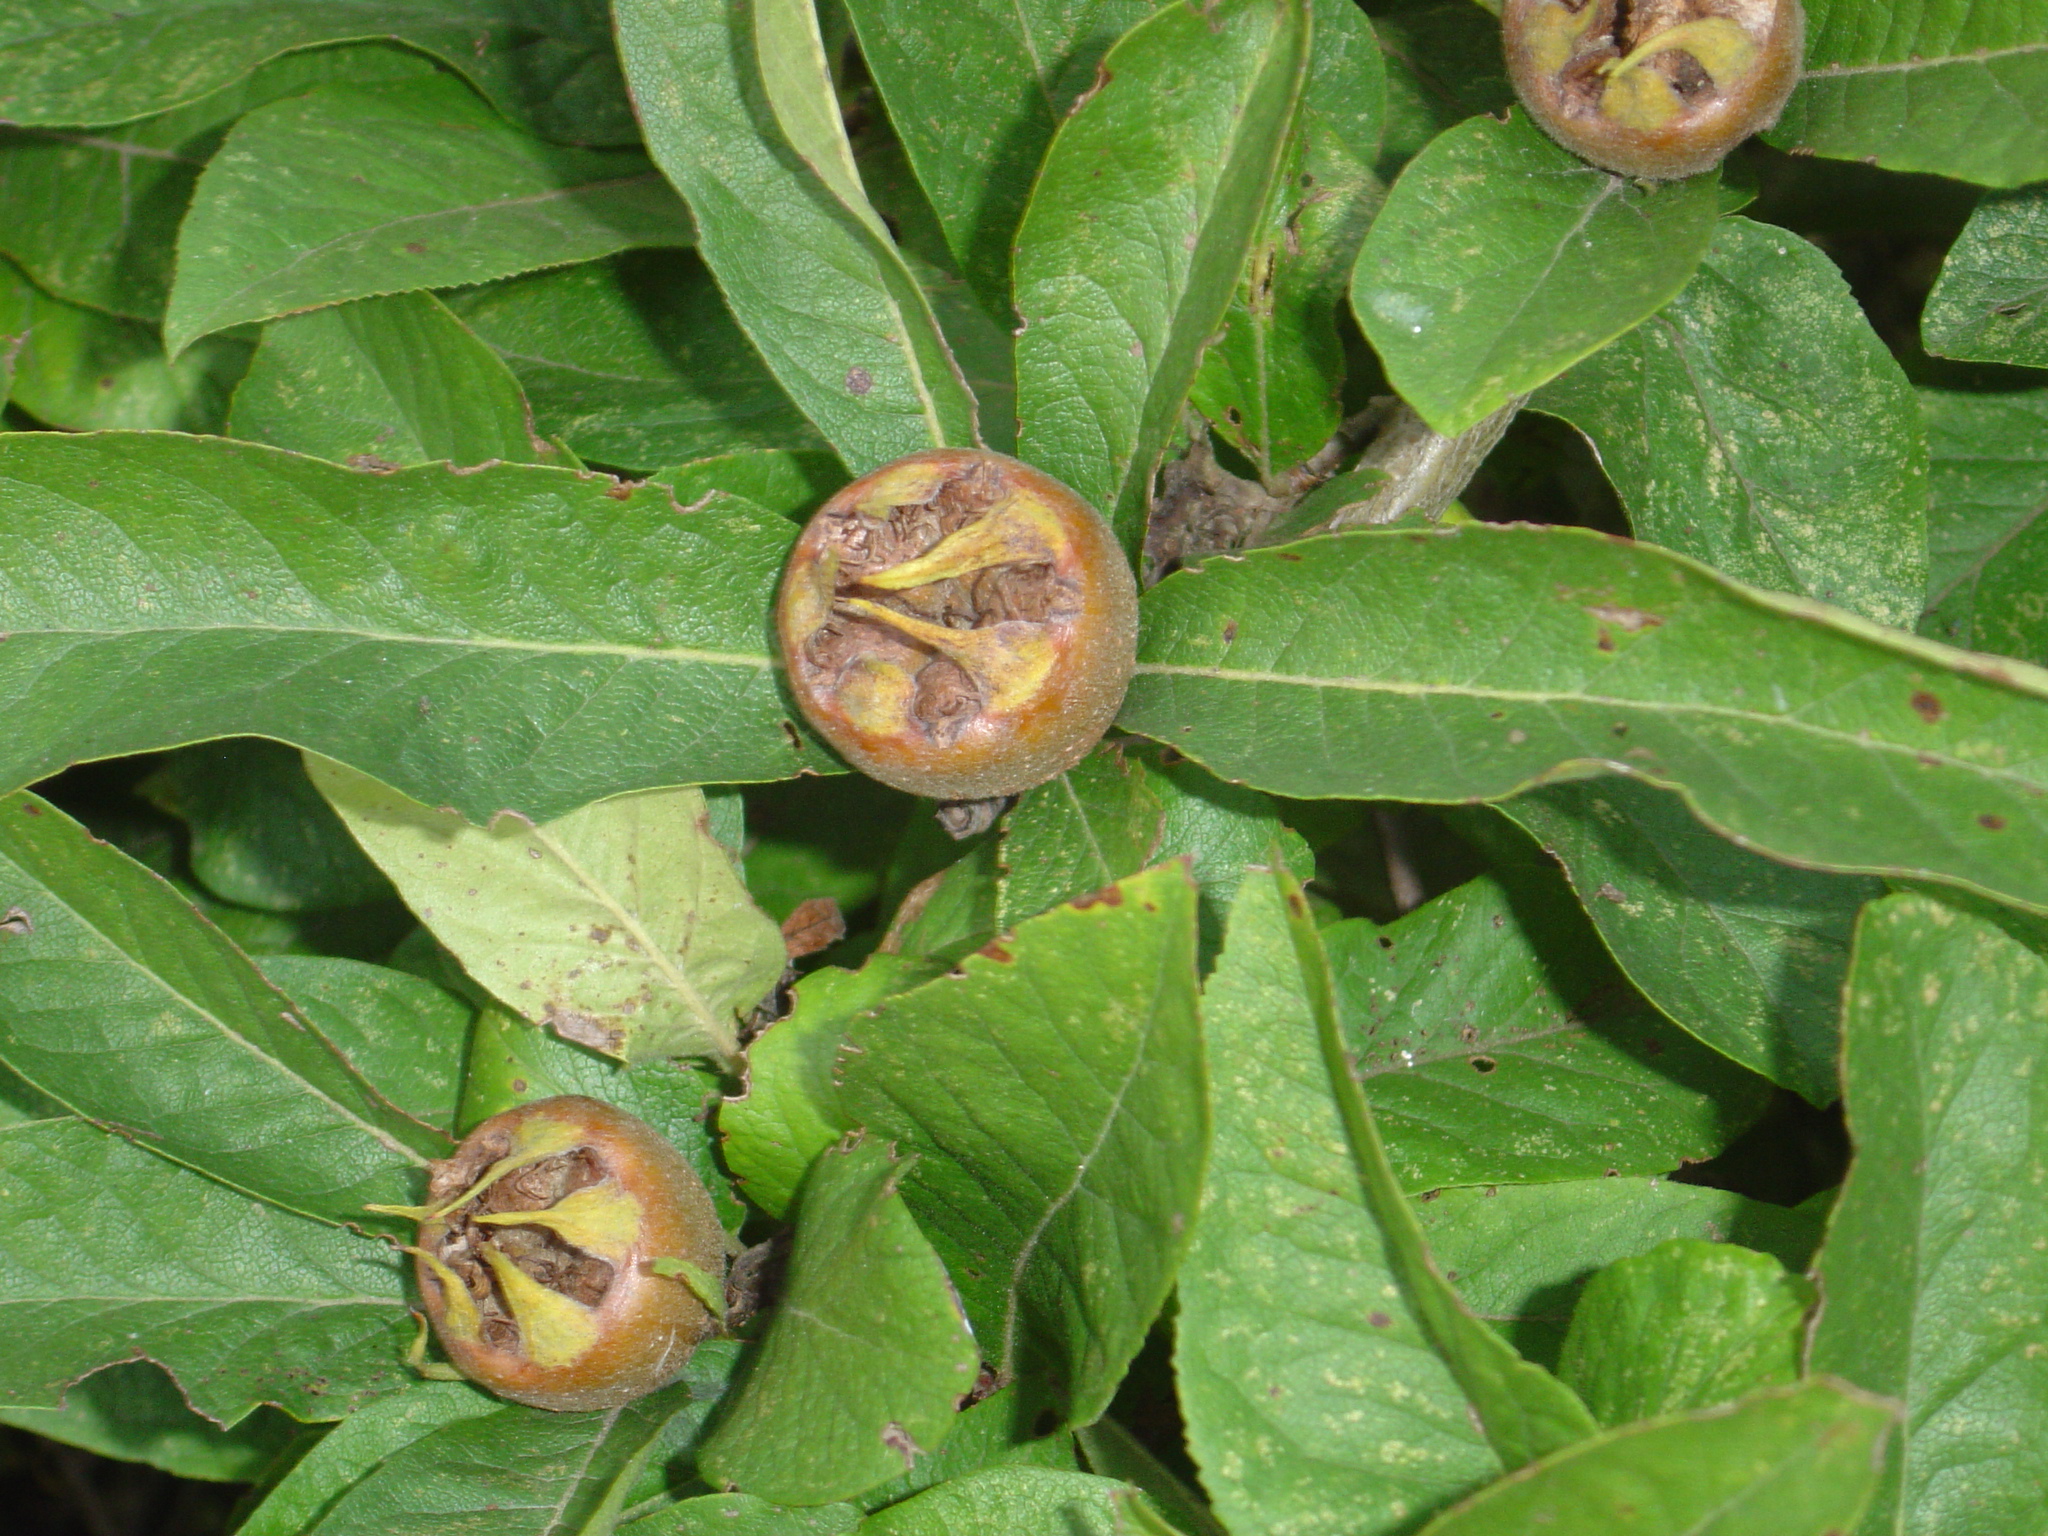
[0,1120,418,1423]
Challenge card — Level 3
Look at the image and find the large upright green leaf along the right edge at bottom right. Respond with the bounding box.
[1808,895,2048,1536]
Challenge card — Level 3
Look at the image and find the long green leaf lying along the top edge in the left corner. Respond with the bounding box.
[0,0,633,143]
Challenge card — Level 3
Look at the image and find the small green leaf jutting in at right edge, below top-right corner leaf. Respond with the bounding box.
[1921,182,2048,369]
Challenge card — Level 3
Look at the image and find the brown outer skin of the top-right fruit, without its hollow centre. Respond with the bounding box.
[1501,0,1806,180]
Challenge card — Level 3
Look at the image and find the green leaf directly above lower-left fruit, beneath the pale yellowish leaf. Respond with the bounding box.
[457,1004,748,1233]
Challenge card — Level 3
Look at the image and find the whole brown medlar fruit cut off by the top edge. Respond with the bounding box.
[1501,0,1806,180]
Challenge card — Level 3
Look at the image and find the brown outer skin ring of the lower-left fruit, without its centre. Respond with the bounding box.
[414,1096,725,1411]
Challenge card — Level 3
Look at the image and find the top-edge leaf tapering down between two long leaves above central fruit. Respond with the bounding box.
[848,0,1153,313]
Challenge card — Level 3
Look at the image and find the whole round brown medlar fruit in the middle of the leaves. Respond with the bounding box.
[776,449,1137,801]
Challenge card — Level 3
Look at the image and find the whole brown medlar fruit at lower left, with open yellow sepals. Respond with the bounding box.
[414,1096,725,1409]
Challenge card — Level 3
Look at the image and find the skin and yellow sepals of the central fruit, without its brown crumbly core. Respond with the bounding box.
[776,449,1137,801]
